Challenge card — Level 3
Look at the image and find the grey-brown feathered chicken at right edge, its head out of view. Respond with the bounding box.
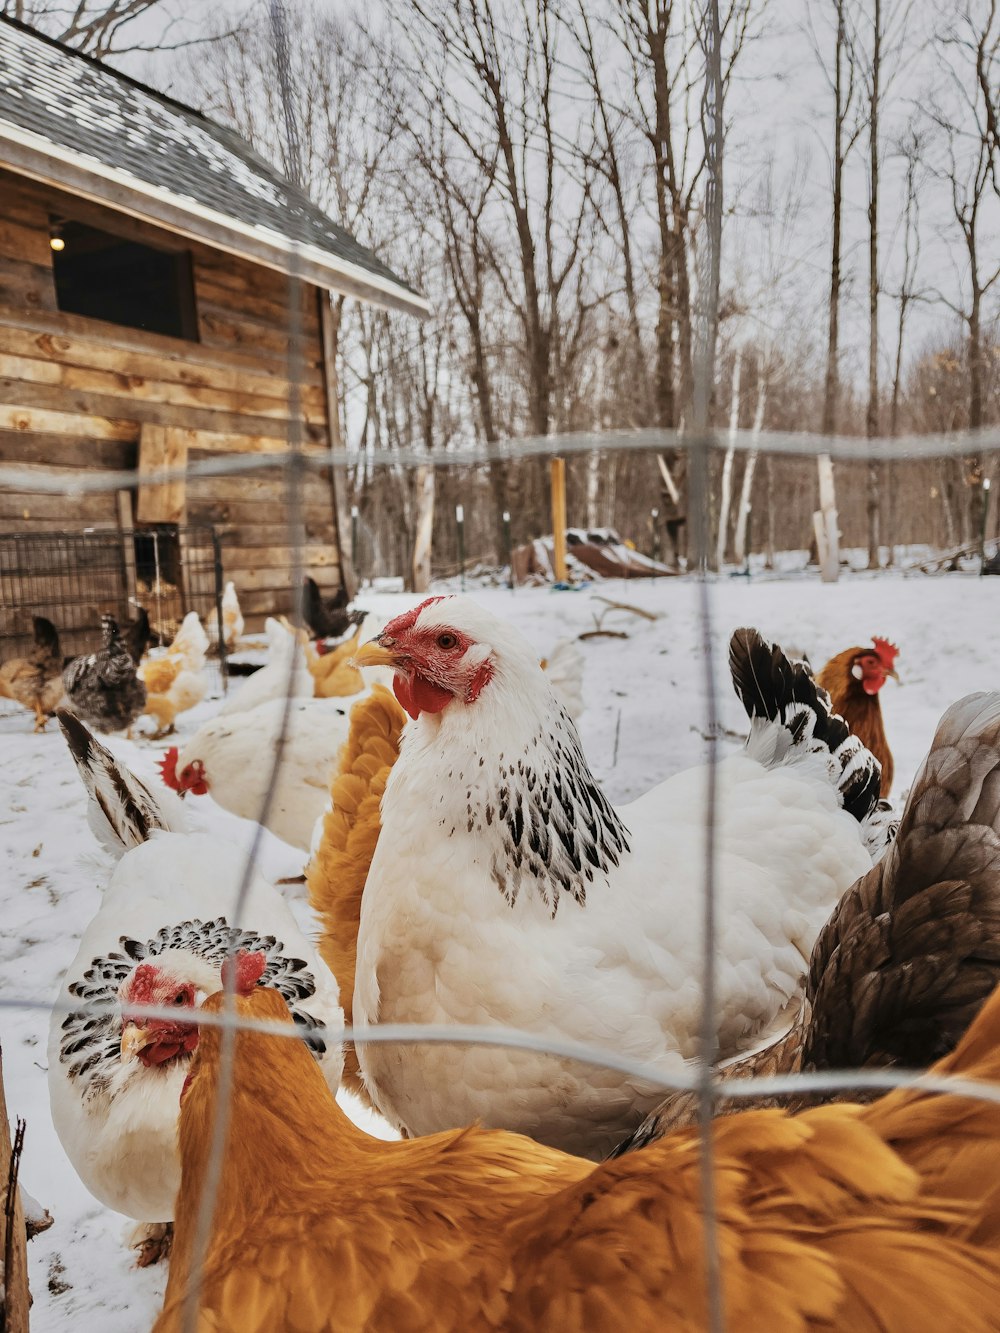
[617,692,1000,1154]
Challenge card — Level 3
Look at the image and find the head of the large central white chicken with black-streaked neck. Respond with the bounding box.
[355,597,541,718]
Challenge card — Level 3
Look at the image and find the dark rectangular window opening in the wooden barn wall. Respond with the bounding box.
[51,217,197,341]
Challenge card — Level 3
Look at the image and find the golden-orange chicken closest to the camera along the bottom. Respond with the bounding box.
[153,954,1000,1333]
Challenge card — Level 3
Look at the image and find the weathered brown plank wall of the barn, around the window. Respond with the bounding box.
[0,172,340,628]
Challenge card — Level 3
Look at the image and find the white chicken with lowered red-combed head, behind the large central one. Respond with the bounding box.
[161,693,355,852]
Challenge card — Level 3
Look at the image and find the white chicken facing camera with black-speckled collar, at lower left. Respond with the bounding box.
[48,713,343,1260]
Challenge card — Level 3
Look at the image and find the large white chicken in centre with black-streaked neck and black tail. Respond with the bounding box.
[353,597,879,1157]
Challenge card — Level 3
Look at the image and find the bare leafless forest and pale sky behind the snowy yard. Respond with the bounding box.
[3,0,1000,573]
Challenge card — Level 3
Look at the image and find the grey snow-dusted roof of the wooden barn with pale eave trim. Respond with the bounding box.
[0,17,427,315]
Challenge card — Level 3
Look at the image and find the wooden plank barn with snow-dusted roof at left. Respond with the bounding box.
[0,19,427,656]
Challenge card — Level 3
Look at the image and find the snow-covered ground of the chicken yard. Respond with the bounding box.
[0,575,1000,1333]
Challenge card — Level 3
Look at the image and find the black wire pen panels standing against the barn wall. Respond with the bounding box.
[0,525,225,664]
